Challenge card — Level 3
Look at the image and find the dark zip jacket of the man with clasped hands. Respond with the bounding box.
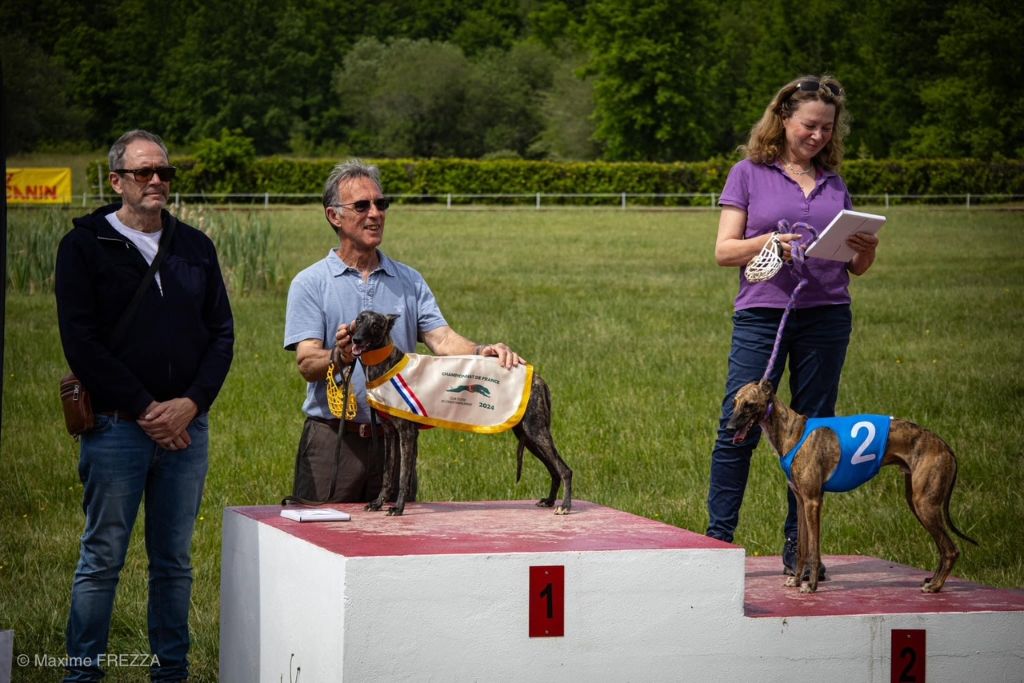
[54,204,234,416]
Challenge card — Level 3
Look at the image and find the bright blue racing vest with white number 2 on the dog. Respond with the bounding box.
[778,415,892,493]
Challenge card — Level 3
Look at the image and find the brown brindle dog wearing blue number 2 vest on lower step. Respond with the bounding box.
[728,381,978,593]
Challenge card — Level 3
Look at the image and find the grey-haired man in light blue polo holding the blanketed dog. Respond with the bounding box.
[285,160,523,503]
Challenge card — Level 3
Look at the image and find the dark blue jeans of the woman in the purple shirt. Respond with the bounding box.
[708,304,853,543]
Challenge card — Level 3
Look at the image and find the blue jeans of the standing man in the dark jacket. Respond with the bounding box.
[65,414,209,681]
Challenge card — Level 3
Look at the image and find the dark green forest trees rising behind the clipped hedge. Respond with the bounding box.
[0,0,1024,162]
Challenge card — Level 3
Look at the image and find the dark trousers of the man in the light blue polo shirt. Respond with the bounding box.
[292,417,417,503]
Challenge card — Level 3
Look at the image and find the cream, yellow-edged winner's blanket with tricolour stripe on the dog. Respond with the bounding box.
[367,353,534,434]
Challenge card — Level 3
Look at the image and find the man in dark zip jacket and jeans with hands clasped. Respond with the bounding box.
[55,130,234,681]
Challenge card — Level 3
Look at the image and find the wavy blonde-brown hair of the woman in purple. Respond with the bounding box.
[739,74,850,171]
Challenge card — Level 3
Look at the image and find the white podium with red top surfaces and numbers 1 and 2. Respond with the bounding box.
[220,501,1024,683]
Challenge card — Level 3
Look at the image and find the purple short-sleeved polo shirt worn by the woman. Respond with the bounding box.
[718,159,853,310]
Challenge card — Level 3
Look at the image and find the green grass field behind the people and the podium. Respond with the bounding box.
[0,206,1024,681]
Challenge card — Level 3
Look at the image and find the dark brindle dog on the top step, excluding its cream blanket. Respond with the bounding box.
[351,310,572,515]
